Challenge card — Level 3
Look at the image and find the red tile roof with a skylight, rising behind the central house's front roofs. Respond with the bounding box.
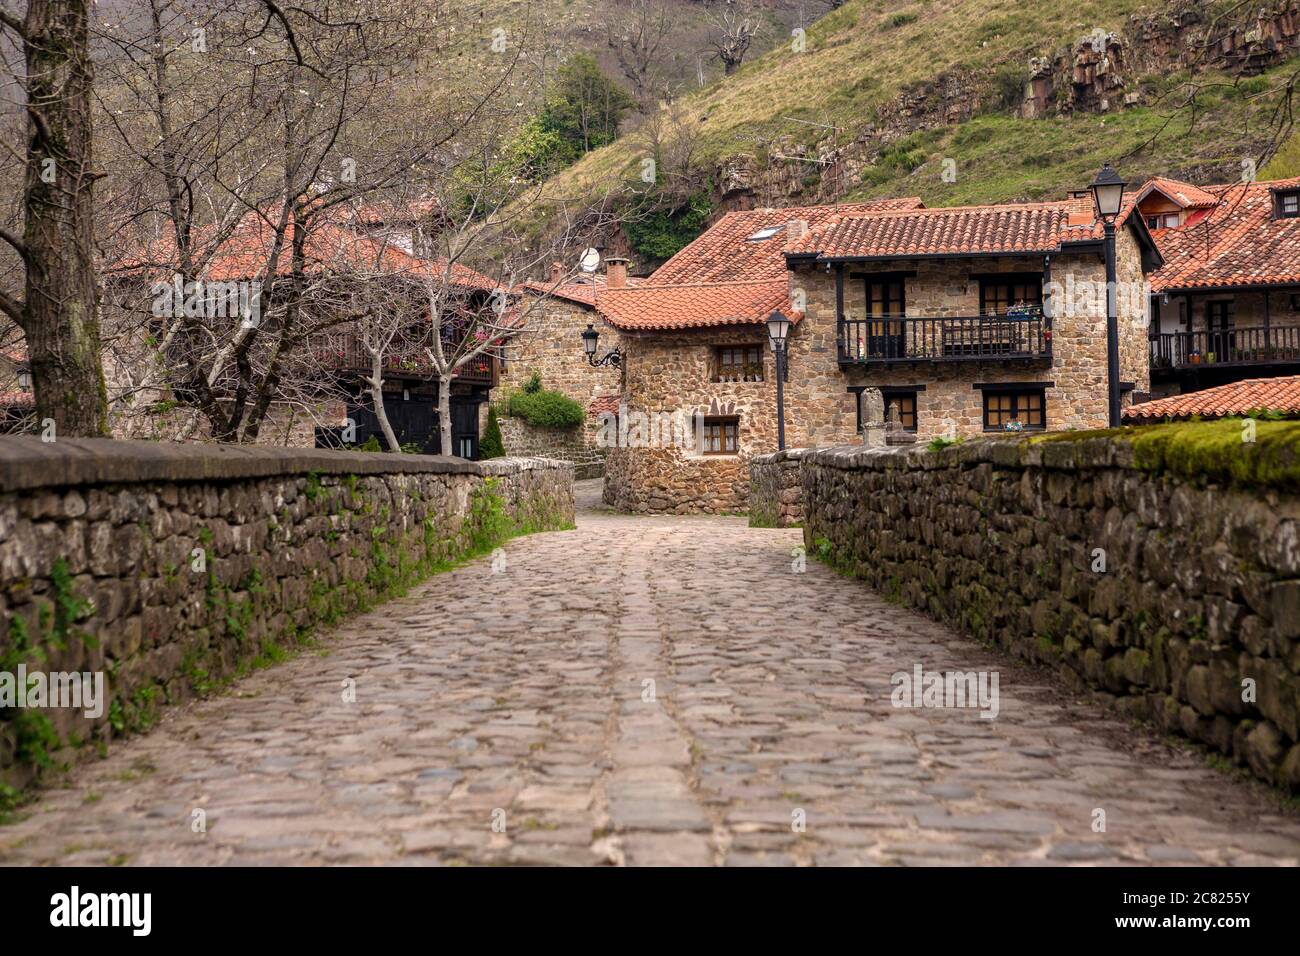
[650,196,924,285]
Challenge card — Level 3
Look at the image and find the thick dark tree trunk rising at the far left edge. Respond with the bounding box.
[22,0,109,437]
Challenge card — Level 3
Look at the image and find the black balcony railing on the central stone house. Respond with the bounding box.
[839,311,1052,363]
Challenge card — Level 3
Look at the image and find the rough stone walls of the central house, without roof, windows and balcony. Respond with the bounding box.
[605,229,1149,514]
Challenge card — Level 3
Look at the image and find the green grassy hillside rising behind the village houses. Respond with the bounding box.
[514,0,1295,256]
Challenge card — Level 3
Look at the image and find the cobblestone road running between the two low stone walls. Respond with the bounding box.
[0,483,1300,865]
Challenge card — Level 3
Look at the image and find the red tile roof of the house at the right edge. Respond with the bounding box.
[1151,178,1300,291]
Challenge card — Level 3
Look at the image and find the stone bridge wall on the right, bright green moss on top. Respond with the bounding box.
[801,434,1300,790]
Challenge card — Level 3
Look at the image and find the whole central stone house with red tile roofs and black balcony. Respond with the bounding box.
[585,189,1161,512]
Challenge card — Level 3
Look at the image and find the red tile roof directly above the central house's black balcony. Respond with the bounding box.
[785,198,1134,259]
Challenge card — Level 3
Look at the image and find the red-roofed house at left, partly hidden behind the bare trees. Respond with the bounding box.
[105,203,499,458]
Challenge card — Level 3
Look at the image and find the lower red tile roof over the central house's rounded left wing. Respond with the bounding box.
[598,276,800,329]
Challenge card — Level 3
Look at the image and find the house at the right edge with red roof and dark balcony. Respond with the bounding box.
[1136,178,1300,394]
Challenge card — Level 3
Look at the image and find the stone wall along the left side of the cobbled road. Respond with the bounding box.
[0,438,573,786]
